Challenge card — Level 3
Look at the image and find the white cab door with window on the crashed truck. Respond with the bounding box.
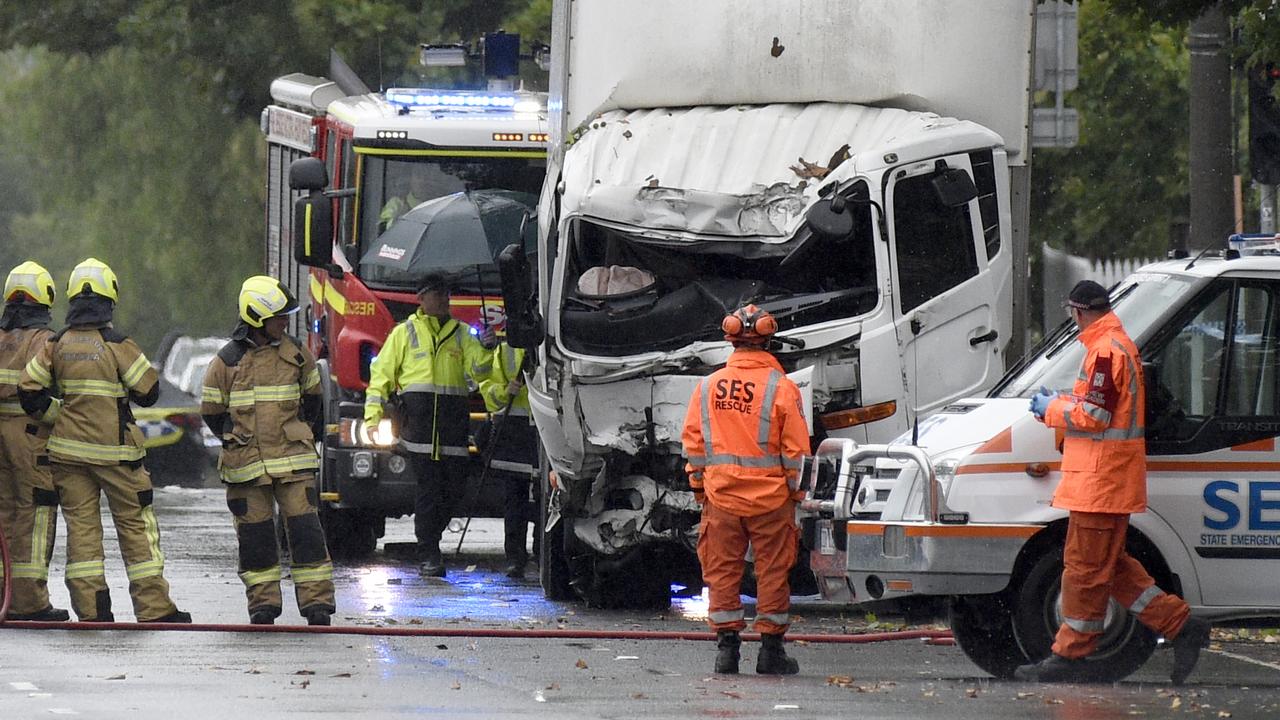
[886,155,1001,414]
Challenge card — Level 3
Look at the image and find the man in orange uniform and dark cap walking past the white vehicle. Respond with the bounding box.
[1015,281,1210,684]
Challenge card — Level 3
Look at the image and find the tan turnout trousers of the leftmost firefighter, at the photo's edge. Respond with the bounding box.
[0,416,58,615]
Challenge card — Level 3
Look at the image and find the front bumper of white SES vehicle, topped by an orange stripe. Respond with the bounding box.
[846,520,1043,601]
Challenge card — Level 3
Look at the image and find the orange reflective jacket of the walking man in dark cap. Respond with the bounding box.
[1044,313,1147,514]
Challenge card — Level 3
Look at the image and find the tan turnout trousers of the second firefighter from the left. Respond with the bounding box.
[51,461,178,621]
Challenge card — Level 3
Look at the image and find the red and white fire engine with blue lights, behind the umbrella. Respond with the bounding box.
[261,36,547,556]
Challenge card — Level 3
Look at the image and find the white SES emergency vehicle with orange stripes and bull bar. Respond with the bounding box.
[801,236,1280,682]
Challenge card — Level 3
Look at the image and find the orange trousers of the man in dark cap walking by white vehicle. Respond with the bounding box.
[1053,510,1190,659]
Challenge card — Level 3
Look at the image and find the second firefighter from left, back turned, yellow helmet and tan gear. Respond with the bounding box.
[18,258,191,623]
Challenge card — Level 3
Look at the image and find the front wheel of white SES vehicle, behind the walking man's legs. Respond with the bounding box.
[1012,546,1156,683]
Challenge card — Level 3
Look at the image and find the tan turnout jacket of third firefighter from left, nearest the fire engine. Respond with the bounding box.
[200,336,321,483]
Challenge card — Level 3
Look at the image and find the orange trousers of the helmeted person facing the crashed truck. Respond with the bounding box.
[698,501,797,635]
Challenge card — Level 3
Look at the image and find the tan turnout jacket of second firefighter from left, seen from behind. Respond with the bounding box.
[18,325,160,465]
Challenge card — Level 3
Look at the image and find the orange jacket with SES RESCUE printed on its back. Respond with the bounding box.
[681,347,809,516]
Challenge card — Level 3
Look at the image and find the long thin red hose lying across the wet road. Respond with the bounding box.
[0,620,951,643]
